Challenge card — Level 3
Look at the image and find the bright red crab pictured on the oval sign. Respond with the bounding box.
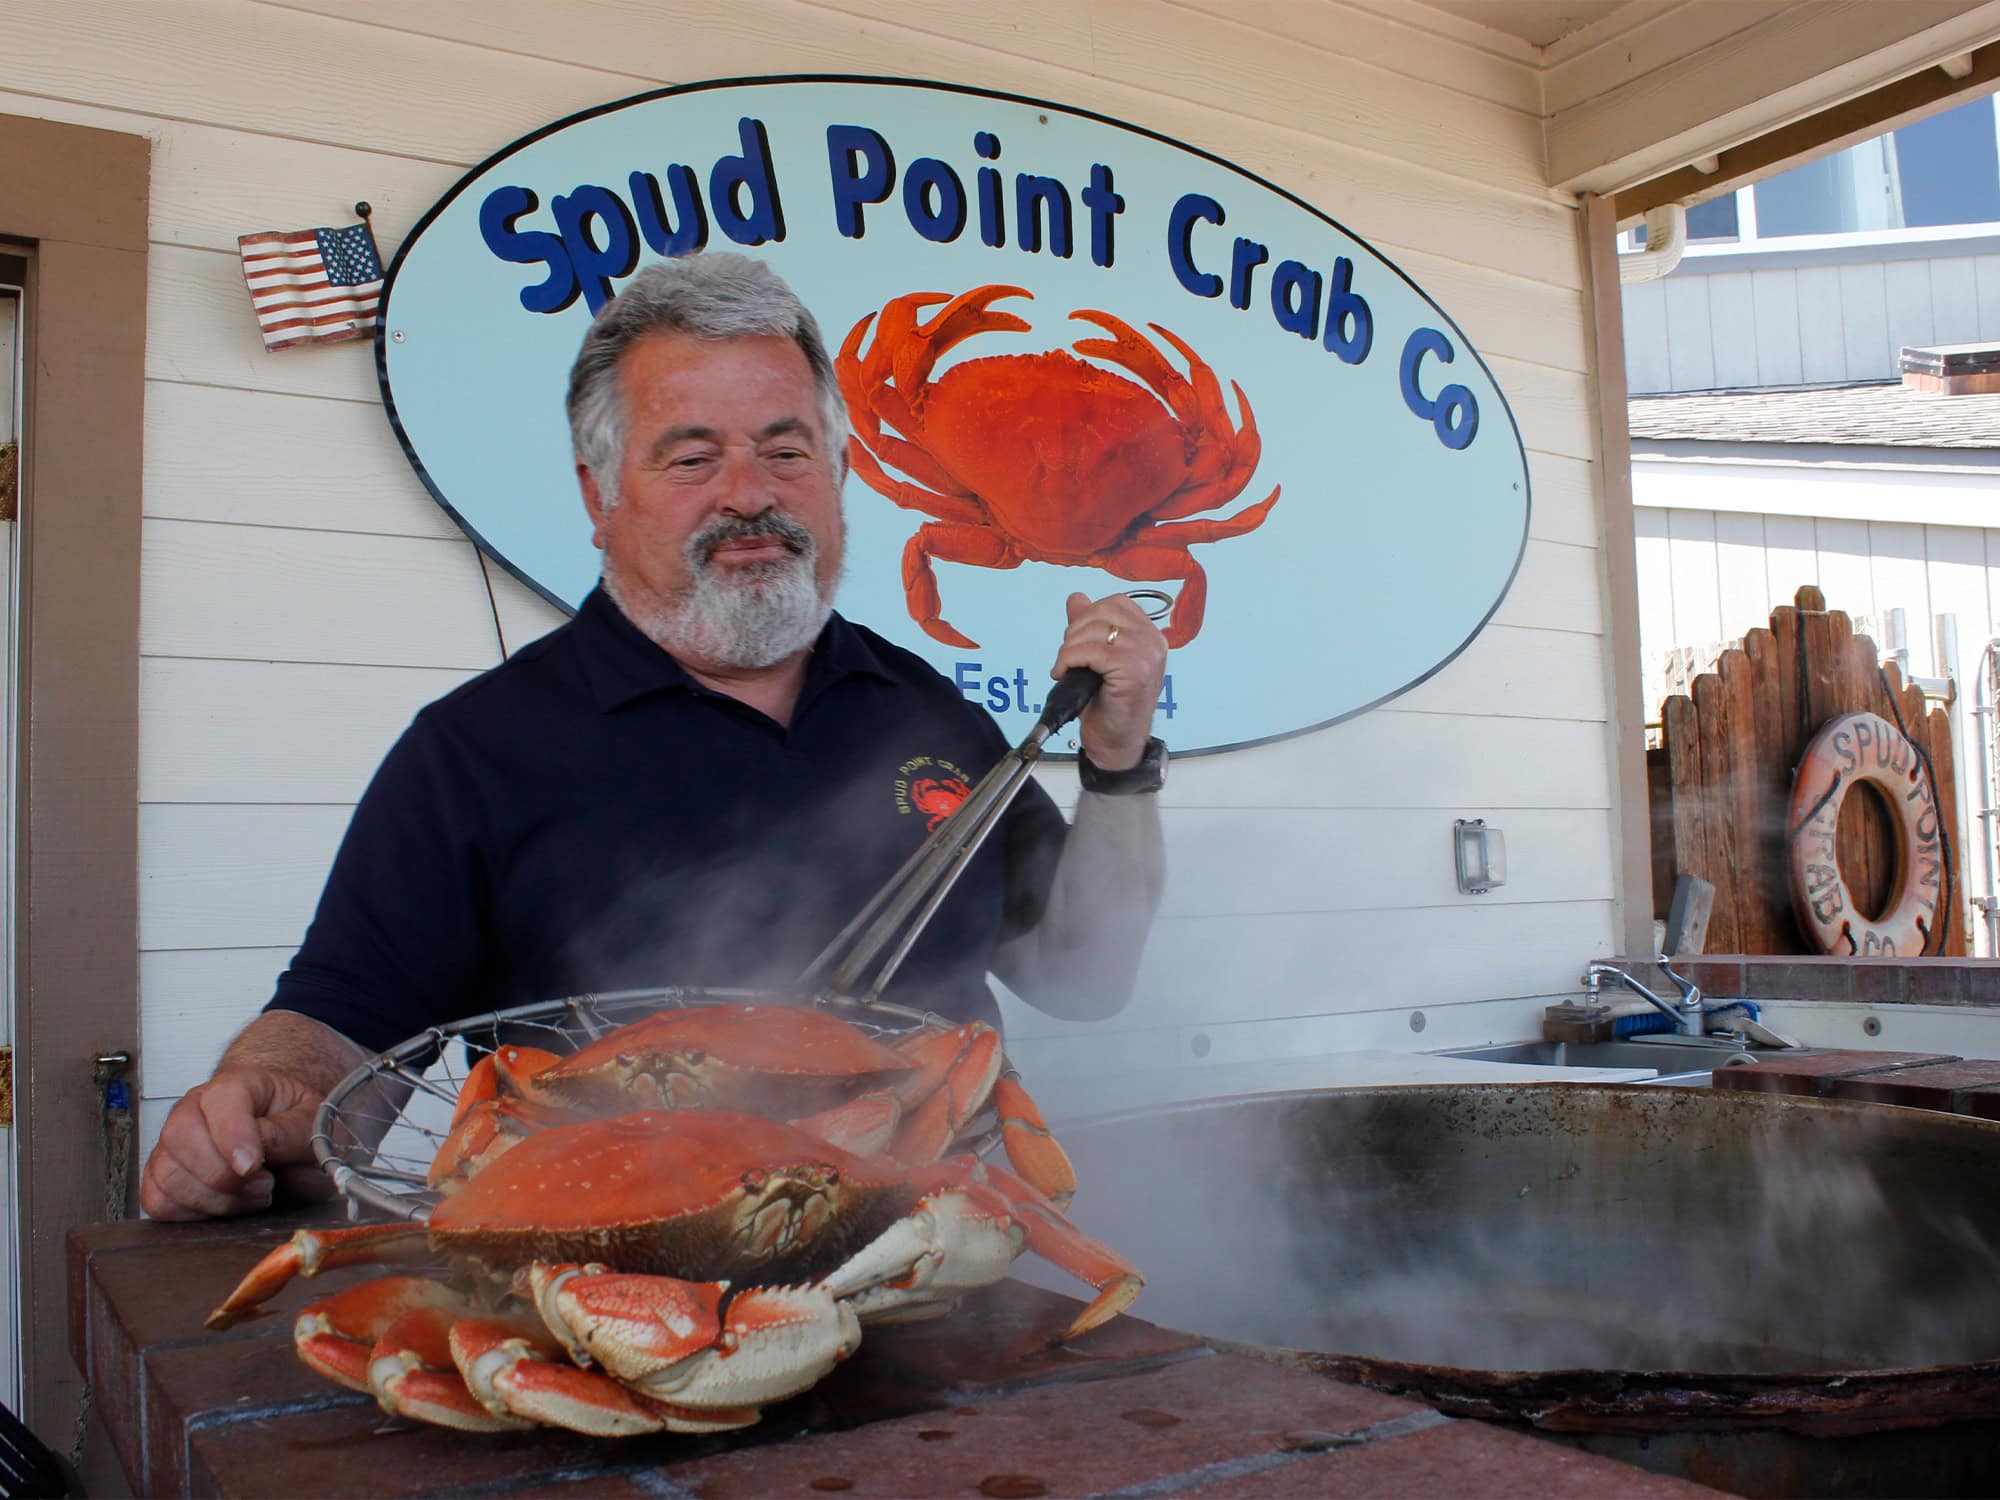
[834,286,1278,646]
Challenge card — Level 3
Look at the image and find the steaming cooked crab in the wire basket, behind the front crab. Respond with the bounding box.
[430,1004,1076,1208]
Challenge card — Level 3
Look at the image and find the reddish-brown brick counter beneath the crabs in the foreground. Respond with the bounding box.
[70,1210,1714,1500]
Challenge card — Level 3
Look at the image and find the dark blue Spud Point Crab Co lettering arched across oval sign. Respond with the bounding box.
[480,116,1480,450]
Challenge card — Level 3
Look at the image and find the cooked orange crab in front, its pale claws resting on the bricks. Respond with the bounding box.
[208,1110,1144,1436]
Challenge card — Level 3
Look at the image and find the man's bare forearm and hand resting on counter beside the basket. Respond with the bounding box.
[138,1010,368,1218]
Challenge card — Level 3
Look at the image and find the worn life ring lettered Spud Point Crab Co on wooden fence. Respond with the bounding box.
[1786,714,1944,958]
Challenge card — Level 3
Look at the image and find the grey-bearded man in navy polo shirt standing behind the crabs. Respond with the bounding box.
[140,254,1166,1218]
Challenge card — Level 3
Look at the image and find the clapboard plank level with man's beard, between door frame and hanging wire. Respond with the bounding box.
[140,520,500,668]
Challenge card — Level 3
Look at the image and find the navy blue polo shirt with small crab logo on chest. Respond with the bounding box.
[270,590,1064,1050]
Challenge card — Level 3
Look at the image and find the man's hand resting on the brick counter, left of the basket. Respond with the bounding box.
[138,1068,332,1218]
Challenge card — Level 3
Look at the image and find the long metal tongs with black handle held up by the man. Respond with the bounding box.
[798,666,1104,1004]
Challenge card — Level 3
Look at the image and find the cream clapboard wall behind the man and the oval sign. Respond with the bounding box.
[0,0,1614,1136]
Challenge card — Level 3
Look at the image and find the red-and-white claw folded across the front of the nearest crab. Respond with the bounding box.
[528,1262,862,1410]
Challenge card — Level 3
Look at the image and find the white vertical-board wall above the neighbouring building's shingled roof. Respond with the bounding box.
[1624,238,2000,396]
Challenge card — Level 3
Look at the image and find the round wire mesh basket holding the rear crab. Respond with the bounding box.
[312,988,960,1222]
